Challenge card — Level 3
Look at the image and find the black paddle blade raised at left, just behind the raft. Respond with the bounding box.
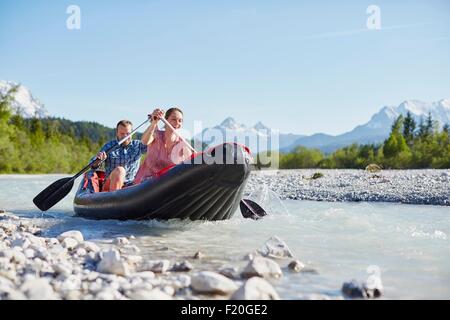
[33,178,73,211]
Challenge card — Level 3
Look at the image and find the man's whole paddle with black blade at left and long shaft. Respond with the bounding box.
[33,118,150,211]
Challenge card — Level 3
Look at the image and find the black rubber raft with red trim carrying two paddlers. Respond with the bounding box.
[74,143,251,220]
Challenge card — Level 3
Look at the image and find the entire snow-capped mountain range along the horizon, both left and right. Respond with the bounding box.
[0,80,450,153]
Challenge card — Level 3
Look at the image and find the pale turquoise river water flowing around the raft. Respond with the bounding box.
[0,175,450,299]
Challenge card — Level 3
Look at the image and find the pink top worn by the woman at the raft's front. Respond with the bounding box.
[133,130,192,184]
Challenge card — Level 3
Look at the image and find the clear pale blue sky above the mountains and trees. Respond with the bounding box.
[0,0,450,134]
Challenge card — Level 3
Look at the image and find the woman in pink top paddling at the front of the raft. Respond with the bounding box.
[133,108,192,184]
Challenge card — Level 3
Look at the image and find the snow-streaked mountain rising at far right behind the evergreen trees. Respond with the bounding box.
[282,99,450,152]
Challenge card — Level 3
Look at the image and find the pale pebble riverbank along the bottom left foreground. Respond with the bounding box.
[0,211,382,300]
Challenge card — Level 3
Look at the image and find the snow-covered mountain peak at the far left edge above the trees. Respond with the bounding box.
[0,80,49,118]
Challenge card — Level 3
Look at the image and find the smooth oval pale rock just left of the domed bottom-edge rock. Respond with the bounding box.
[191,271,238,294]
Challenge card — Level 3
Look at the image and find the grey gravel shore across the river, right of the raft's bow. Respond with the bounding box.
[246,169,450,206]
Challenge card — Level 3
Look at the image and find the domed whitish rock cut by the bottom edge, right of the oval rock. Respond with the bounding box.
[231,277,280,300]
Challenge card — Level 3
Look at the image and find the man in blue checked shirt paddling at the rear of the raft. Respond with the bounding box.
[97,120,154,192]
